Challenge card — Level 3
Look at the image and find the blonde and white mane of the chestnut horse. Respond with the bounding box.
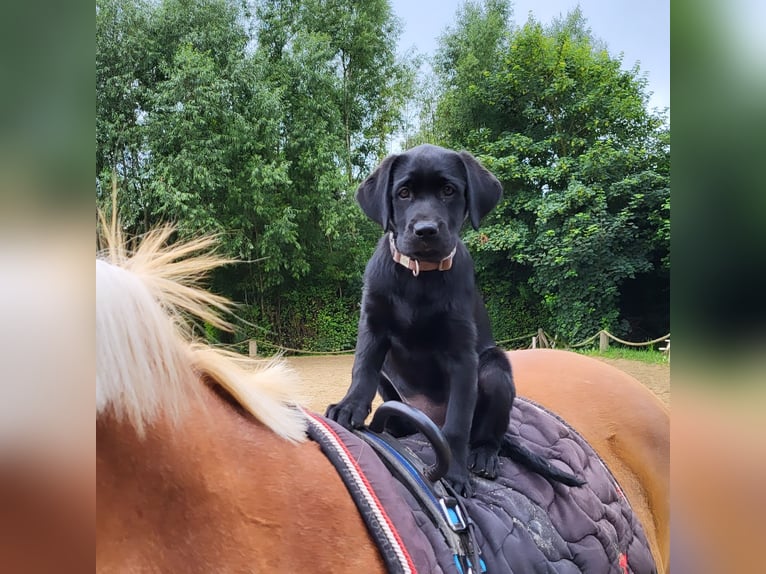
[96,217,305,441]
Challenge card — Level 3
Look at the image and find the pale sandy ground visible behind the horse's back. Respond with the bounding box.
[287,355,670,413]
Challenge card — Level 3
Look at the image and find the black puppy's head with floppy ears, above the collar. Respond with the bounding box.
[356,144,502,261]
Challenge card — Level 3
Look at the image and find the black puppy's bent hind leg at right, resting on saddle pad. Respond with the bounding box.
[468,347,516,479]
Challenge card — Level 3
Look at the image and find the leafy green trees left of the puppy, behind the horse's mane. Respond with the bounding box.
[96,0,413,347]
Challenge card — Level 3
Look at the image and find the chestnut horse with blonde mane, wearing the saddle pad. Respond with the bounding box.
[96,226,669,573]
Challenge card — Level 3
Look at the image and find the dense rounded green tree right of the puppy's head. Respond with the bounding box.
[426,2,670,342]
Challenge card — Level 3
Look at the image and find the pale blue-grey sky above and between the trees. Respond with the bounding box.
[391,0,670,115]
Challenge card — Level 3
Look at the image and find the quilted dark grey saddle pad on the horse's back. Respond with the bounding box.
[312,398,656,574]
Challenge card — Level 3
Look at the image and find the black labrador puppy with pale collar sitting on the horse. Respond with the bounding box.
[327,145,576,496]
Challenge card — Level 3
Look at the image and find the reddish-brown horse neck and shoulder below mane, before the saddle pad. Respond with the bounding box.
[96,390,385,574]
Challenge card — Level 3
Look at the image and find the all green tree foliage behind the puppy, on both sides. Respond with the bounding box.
[96,0,670,350]
